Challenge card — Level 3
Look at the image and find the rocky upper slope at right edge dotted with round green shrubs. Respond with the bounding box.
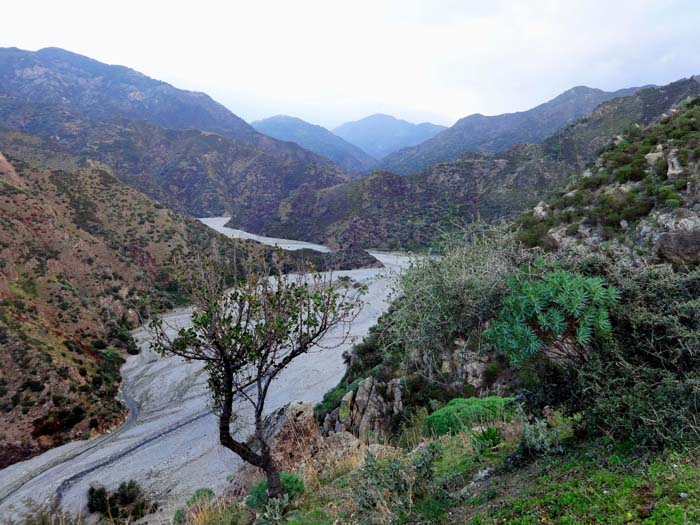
[520,99,700,256]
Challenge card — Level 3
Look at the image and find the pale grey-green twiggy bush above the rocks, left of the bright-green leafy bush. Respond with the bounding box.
[387,224,529,370]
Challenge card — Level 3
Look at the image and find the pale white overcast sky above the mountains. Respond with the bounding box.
[0,0,700,127]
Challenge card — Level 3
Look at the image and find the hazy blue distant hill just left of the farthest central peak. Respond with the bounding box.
[251,115,377,173]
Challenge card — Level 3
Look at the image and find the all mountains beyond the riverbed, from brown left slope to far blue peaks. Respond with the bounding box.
[0,43,700,468]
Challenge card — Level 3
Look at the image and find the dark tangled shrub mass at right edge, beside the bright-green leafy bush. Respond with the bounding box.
[579,265,700,447]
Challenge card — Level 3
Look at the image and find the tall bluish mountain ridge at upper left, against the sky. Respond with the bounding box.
[0,48,257,141]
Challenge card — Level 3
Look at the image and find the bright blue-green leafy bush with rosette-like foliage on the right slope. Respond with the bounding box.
[485,270,620,365]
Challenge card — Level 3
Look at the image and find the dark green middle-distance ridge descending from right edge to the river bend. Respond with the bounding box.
[270,79,700,248]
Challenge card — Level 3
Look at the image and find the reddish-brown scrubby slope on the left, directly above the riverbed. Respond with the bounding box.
[0,145,274,467]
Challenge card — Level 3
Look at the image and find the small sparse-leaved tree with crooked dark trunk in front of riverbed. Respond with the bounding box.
[151,259,361,498]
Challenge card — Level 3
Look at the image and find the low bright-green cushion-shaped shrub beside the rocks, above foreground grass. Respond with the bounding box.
[423,396,513,436]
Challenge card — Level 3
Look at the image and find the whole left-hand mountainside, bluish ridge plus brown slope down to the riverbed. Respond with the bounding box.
[0,48,376,468]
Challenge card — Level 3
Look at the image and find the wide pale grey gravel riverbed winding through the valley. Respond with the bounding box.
[0,217,408,523]
